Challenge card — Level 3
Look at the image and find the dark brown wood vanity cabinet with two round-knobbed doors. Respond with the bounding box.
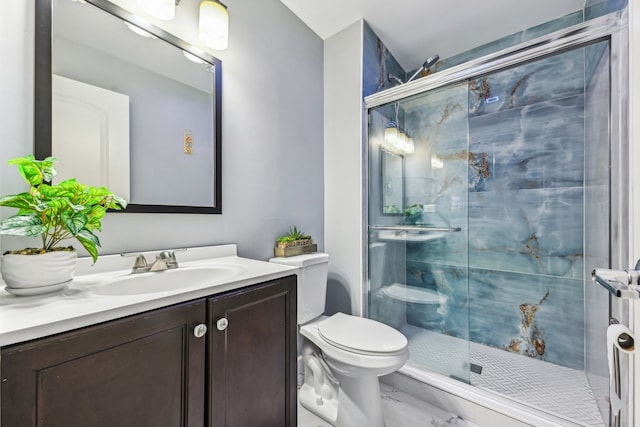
[0,276,296,427]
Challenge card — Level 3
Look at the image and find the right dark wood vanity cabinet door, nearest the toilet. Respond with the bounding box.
[209,276,297,427]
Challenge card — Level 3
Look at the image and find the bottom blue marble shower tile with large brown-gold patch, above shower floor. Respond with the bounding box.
[469,269,584,369]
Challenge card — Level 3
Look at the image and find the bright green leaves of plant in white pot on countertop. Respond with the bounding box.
[0,155,127,262]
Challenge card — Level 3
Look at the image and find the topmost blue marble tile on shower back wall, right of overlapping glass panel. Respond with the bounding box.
[469,49,584,117]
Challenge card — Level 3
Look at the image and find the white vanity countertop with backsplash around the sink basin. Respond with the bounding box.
[0,245,298,347]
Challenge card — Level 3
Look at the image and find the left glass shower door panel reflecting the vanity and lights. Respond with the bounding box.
[368,82,472,382]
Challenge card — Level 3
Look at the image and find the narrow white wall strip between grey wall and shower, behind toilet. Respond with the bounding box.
[324,21,363,314]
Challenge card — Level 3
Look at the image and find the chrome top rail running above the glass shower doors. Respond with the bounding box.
[364,12,627,108]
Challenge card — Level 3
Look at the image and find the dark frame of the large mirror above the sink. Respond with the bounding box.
[34,0,222,214]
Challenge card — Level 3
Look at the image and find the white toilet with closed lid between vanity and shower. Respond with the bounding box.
[270,253,409,427]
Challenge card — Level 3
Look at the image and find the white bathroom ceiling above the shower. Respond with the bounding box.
[281,0,585,71]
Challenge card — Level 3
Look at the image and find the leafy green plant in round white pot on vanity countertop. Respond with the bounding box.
[0,155,127,293]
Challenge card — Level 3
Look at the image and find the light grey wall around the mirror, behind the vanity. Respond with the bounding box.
[0,0,322,259]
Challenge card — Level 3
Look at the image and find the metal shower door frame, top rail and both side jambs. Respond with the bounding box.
[361,8,634,425]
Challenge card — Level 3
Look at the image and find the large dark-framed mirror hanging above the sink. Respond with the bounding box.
[34,0,222,214]
